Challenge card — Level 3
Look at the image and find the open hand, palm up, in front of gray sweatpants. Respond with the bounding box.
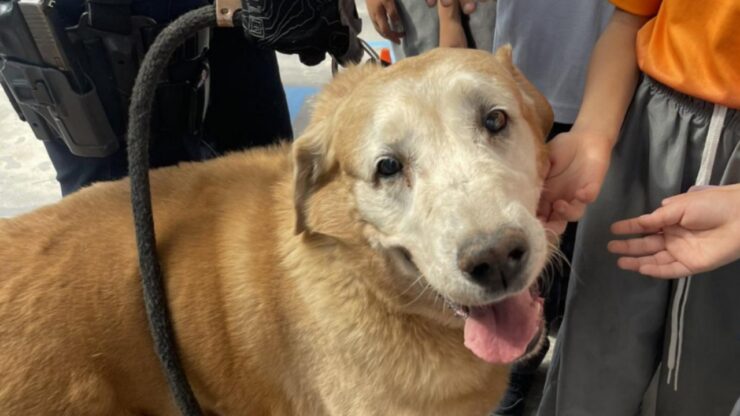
[608,184,740,279]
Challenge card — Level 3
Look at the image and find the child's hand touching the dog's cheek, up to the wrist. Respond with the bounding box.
[537,130,613,234]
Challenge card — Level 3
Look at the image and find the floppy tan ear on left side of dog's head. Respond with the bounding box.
[293,64,382,234]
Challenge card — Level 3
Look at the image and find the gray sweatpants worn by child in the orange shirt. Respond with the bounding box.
[538,77,740,416]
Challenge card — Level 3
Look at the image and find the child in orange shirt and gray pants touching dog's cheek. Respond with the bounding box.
[539,0,740,416]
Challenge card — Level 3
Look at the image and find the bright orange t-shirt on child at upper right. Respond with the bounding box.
[611,0,740,108]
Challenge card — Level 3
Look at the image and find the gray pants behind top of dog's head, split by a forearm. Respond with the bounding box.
[393,0,496,58]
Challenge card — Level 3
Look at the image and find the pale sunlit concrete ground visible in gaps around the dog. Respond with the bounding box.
[0,2,554,415]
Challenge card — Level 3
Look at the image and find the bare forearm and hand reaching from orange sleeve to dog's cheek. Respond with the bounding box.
[537,9,647,237]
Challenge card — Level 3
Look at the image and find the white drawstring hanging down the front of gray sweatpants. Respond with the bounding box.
[666,105,727,391]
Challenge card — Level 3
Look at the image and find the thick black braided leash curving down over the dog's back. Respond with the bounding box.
[126,6,216,416]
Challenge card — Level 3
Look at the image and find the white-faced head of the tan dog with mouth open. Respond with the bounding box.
[294,47,552,361]
